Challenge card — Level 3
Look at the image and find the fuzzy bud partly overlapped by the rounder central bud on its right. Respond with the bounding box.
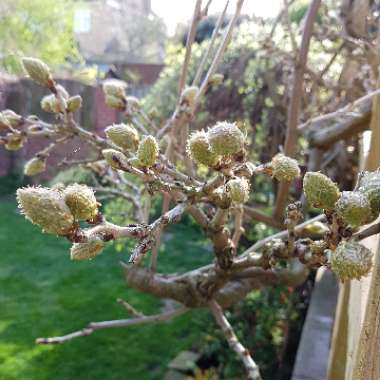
[187,131,219,166]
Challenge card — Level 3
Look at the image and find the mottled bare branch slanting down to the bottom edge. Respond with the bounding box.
[209,300,262,380]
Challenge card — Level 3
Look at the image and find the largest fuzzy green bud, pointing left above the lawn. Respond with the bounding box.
[17,187,74,235]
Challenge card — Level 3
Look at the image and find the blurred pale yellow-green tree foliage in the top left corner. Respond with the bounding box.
[0,0,79,72]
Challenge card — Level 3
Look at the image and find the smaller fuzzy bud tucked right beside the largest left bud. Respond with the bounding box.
[63,183,98,220]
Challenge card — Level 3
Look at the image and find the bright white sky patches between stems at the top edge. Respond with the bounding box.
[151,0,283,35]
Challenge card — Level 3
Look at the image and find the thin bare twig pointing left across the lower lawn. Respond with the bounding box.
[36,307,187,344]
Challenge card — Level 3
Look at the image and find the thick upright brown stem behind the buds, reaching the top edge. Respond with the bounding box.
[273,0,321,219]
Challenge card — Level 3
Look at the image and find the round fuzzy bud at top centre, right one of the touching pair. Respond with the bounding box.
[207,121,245,156]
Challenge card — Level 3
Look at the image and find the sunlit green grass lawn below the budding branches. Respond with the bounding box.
[0,201,211,380]
